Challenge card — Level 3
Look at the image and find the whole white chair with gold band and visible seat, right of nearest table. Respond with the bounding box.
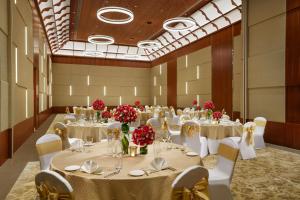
[208,138,239,187]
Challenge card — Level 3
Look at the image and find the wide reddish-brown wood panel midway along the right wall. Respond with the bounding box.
[212,27,234,115]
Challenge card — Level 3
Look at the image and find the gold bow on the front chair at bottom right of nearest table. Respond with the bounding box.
[172,178,210,200]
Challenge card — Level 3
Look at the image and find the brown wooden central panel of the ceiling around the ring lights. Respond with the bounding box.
[70,0,201,46]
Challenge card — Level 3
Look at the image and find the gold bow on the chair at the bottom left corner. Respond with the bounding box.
[36,183,73,200]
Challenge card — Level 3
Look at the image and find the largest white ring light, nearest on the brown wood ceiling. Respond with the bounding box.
[97,6,134,24]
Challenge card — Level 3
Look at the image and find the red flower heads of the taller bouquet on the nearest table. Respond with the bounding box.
[114,105,137,124]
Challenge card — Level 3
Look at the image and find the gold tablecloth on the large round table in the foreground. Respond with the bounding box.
[51,143,202,200]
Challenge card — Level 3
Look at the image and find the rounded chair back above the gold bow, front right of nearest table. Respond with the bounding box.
[172,165,208,189]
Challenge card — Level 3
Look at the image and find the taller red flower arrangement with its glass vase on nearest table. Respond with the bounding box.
[114,105,137,154]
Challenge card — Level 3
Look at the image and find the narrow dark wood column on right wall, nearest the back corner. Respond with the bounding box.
[167,58,177,108]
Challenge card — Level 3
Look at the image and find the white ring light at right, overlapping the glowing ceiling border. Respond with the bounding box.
[163,17,196,31]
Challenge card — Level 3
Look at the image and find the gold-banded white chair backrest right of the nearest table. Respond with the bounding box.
[216,138,239,181]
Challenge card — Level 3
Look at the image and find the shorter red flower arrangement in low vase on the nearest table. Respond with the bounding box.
[132,125,155,154]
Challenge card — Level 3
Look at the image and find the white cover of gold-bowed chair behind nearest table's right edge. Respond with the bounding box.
[181,121,208,158]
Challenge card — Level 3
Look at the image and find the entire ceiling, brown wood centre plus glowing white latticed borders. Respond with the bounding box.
[38,0,242,61]
